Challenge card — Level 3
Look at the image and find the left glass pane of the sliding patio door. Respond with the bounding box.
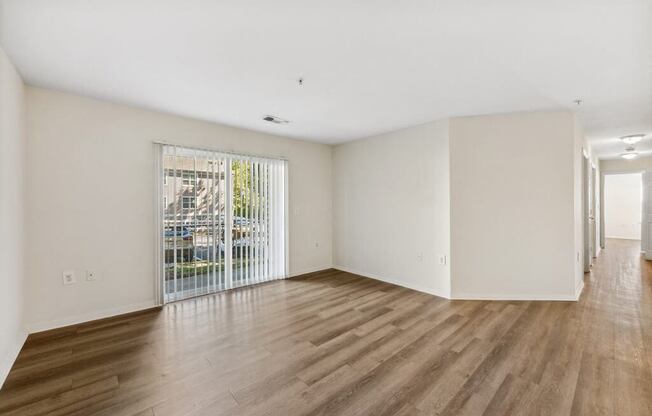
[163,151,226,301]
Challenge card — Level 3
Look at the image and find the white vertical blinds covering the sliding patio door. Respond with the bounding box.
[158,145,287,302]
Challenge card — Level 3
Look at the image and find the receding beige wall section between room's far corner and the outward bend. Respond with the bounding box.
[333,121,450,297]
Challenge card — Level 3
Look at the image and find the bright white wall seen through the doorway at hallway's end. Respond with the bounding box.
[604,173,642,240]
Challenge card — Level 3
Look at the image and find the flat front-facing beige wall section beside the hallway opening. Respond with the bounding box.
[450,112,581,299]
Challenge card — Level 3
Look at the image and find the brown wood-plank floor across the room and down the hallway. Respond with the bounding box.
[0,240,652,416]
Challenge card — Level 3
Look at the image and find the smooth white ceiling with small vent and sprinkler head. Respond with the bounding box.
[0,0,652,148]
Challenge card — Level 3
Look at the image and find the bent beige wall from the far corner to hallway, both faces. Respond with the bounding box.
[333,112,588,300]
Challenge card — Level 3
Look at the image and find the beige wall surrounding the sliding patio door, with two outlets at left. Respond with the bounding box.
[26,87,332,331]
